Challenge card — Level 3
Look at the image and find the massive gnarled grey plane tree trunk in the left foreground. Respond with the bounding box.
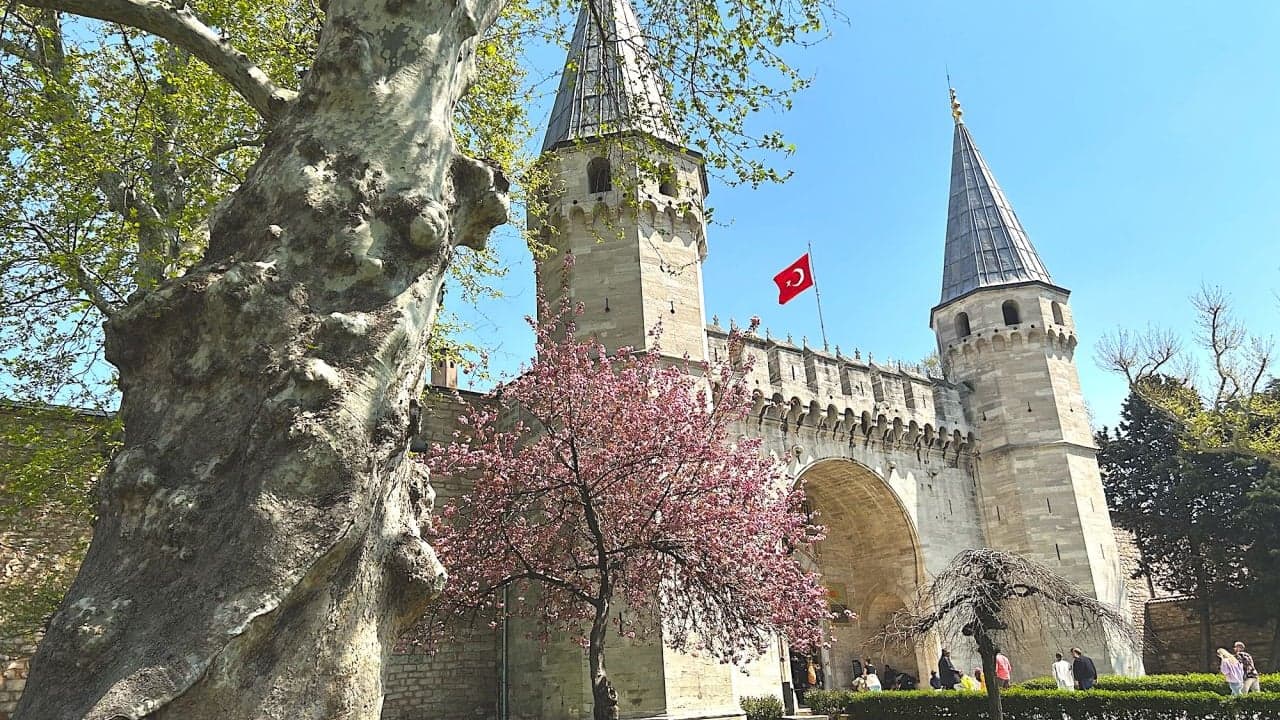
[18,0,506,720]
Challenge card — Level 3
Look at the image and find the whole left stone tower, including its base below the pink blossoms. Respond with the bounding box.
[504,0,780,720]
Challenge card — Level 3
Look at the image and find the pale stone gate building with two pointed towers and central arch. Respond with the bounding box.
[384,0,1140,720]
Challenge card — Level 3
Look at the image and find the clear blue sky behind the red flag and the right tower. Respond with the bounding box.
[448,0,1280,424]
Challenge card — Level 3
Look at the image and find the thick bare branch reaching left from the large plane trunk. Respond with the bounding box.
[19,0,297,120]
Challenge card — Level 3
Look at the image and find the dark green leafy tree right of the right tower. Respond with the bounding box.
[1097,377,1280,669]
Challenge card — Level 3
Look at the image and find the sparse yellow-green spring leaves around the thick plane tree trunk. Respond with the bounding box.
[0,0,835,666]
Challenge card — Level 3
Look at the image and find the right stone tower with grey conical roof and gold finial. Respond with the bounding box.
[929,92,1137,673]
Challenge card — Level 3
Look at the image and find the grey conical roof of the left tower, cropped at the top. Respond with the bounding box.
[543,0,681,152]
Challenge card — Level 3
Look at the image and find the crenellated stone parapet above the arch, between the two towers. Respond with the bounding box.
[707,324,978,460]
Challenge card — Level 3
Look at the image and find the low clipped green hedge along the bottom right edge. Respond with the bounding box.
[847,688,1280,720]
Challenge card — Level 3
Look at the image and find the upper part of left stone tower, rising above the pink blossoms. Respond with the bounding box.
[530,0,707,361]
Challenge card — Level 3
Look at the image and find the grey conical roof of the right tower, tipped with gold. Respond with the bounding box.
[938,92,1053,305]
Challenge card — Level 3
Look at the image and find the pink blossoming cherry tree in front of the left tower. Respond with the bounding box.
[429,311,828,720]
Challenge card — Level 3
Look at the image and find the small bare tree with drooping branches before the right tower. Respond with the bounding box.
[879,548,1137,720]
